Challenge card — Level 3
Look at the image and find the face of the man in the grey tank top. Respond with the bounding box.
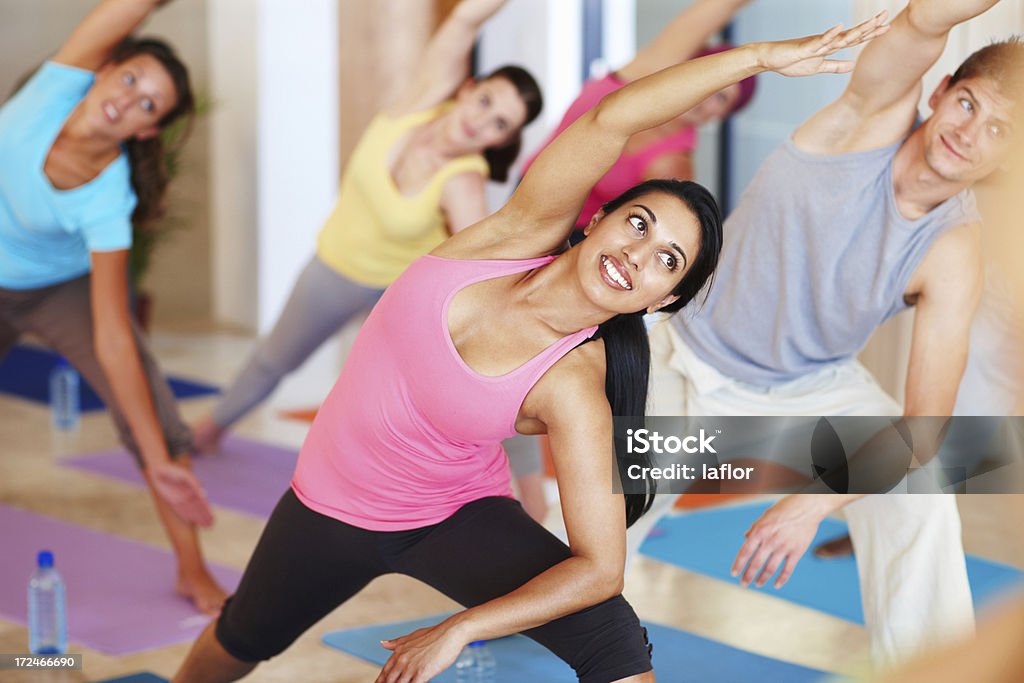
[924,77,1014,183]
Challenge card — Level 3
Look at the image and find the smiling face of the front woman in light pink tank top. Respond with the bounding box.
[575,191,700,313]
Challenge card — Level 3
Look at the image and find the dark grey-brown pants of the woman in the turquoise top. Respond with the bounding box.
[0,275,191,462]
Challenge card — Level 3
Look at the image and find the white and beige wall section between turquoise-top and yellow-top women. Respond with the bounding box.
[208,0,338,332]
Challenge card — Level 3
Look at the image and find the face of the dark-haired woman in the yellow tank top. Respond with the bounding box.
[446,77,526,152]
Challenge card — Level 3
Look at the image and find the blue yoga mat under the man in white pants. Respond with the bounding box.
[640,503,1024,624]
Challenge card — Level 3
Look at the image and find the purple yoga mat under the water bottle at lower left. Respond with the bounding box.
[0,505,242,655]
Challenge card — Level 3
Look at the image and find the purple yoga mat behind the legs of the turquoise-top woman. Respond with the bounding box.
[61,436,296,519]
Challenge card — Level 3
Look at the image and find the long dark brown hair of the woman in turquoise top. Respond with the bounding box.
[111,38,196,231]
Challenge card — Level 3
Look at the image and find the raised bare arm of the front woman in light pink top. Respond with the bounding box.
[500,18,888,253]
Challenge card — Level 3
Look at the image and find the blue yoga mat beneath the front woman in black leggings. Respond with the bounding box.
[324,614,826,683]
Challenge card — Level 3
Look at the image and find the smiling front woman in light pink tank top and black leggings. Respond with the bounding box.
[174,18,885,683]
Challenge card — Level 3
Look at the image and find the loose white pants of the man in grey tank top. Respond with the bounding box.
[627,321,974,666]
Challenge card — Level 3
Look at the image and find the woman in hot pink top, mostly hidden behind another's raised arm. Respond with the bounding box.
[523,0,757,229]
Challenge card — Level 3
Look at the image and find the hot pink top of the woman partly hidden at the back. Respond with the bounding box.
[522,74,697,227]
